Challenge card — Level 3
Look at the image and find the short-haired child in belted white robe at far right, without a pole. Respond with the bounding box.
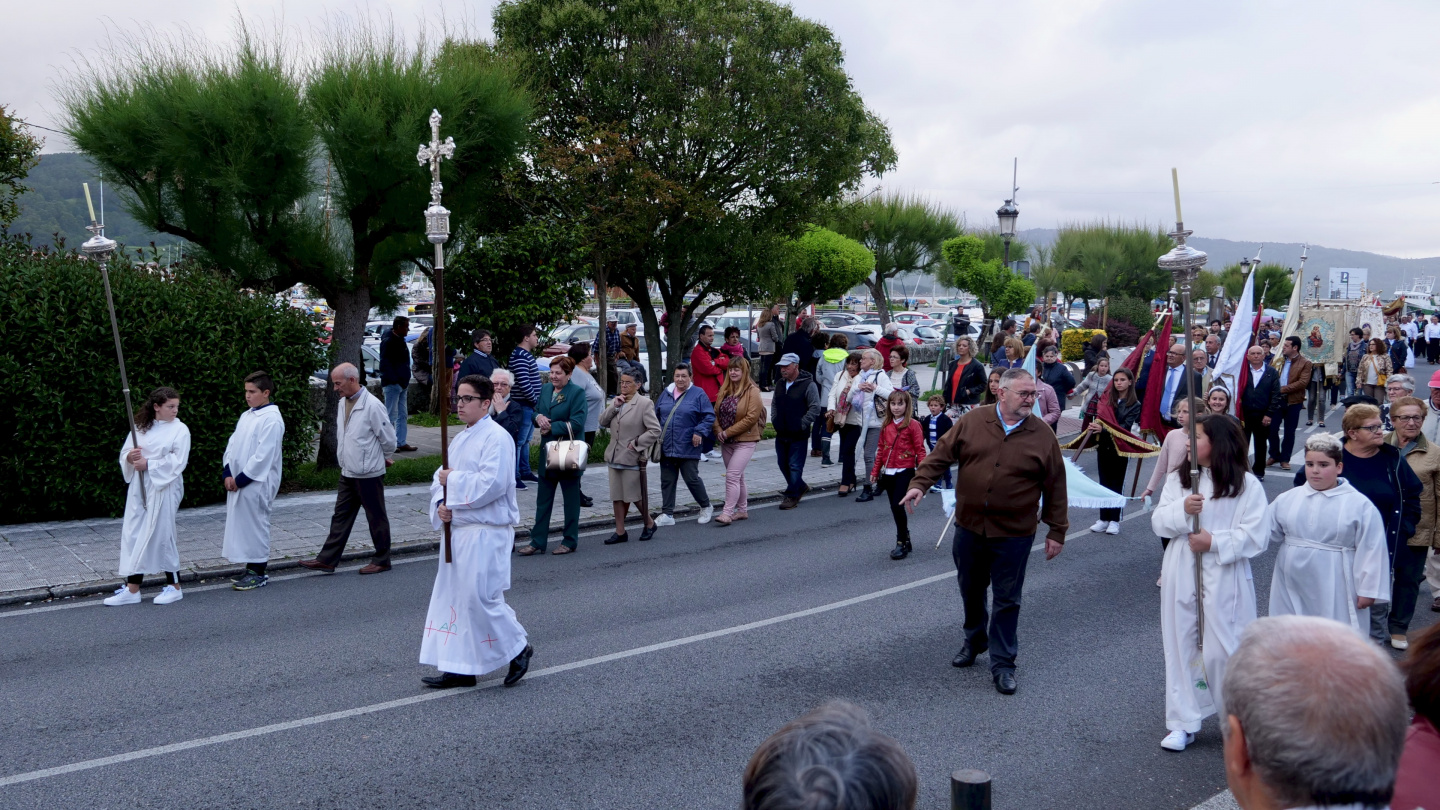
[1269,434,1390,638]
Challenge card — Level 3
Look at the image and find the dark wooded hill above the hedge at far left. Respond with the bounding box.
[10,151,180,248]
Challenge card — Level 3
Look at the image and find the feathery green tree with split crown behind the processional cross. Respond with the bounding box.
[62,27,528,467]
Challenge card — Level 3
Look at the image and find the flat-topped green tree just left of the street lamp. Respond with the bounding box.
[831,195,962,323]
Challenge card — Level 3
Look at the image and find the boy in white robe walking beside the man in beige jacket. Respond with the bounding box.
[220,372,285,591]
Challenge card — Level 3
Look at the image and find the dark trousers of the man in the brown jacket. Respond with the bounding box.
[950,526,1035,672]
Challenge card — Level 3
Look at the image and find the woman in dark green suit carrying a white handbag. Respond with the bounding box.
[520,356,585,556]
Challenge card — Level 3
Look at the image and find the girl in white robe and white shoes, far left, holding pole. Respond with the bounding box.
[105,388,190,607]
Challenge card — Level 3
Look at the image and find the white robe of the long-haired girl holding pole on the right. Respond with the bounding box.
[1151,468,1270,734]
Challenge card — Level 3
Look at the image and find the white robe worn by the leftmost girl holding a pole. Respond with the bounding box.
[117,419,190,577]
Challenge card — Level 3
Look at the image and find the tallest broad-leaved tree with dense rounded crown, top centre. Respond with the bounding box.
[494,0,896,380]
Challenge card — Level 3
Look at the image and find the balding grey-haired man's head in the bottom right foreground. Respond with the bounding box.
[1220,615,1410,807]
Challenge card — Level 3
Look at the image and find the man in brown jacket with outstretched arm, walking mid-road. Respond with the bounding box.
[900,369,1070,695]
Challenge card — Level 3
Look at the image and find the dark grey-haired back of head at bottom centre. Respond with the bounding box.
[742,700,919,810]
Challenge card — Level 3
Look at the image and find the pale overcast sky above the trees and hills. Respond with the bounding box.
[11,0,1440,255]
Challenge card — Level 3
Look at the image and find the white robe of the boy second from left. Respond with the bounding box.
[222,404,285,562]
